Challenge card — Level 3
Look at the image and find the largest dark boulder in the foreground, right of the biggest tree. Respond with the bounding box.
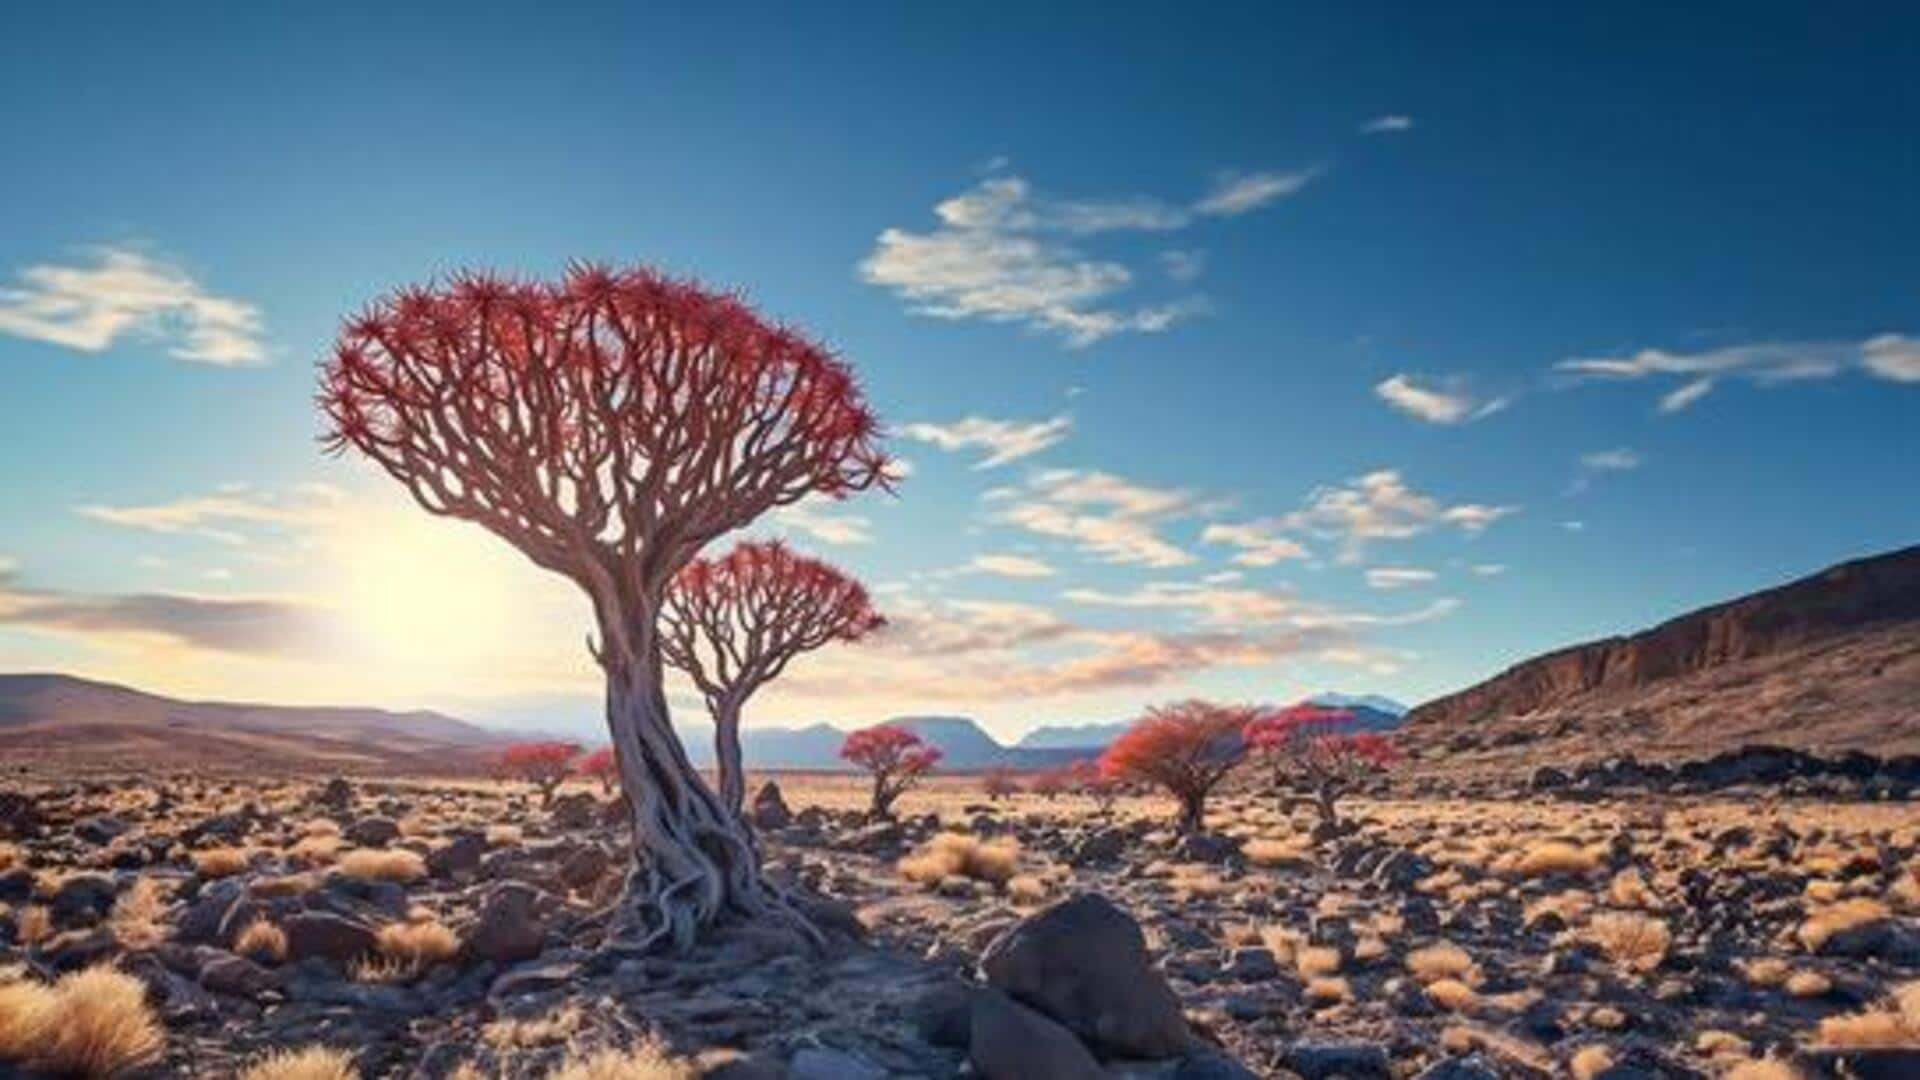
[979,894,1192,1057]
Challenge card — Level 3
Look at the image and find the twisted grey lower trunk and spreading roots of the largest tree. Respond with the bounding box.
[607,634,818,951]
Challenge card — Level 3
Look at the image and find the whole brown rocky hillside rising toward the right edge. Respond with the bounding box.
[1404,546,1920,757]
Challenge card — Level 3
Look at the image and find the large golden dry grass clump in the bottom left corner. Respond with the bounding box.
[0,967,167,1076]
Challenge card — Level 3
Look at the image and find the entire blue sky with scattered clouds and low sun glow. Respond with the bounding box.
[0,4,1920,734]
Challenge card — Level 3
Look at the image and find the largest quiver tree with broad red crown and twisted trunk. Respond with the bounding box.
[319,265,889,947]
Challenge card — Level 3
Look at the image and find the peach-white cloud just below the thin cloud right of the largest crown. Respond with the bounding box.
[995,469,1194,567]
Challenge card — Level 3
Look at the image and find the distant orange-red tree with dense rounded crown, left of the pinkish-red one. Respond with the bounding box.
[1100,700,1260,832]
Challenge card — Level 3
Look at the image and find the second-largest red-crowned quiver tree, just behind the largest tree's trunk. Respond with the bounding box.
[660,540,885,817]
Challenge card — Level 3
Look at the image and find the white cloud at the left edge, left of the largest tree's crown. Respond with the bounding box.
[0,248,267,367]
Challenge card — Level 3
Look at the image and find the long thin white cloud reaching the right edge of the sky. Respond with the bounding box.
[1553,334,1920,413]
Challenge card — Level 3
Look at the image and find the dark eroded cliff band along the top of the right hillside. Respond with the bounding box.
[1407,546,1920,730]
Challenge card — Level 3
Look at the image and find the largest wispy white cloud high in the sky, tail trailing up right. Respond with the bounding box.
[860,173,1313,348]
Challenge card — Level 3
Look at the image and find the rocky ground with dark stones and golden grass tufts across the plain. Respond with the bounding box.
[0,778,1920,1080]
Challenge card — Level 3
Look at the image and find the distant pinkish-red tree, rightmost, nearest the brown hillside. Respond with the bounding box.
[1242,703,1394,826]
